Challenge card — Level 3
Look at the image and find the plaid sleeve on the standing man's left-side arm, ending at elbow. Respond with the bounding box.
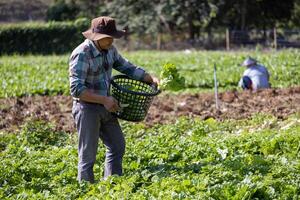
[69,53,89,98]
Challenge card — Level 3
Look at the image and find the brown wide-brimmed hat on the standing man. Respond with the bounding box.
[82,16,125,41]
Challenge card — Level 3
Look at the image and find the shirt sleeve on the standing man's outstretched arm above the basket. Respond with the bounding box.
[113,50,145,80]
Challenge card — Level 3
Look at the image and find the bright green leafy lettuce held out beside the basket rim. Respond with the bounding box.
[159,63,185,91]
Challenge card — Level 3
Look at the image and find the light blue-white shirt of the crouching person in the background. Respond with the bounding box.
[239,65,270,90]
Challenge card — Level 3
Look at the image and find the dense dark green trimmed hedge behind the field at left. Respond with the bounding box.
[0,19,89,55]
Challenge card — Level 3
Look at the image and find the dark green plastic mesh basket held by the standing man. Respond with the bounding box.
[111,75,160,122]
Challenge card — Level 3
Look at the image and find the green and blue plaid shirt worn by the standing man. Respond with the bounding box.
[69,39,145,98]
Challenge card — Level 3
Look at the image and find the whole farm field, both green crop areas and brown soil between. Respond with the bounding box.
[0,50,300,200]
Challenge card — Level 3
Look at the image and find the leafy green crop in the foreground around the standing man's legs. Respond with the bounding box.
[0,114,300,199]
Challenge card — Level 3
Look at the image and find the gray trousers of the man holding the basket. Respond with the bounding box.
[72,101,125,183]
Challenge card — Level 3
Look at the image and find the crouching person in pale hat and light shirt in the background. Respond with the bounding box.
[239,57,270,91]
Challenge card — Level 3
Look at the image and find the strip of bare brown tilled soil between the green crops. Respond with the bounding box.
[0,86,300,132]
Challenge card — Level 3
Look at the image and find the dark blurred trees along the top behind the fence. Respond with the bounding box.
[47,0,300,39]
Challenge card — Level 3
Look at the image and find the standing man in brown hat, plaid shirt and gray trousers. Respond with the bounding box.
[69,16,158,183]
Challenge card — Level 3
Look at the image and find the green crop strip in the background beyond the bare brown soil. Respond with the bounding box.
[0,50,300,97]
